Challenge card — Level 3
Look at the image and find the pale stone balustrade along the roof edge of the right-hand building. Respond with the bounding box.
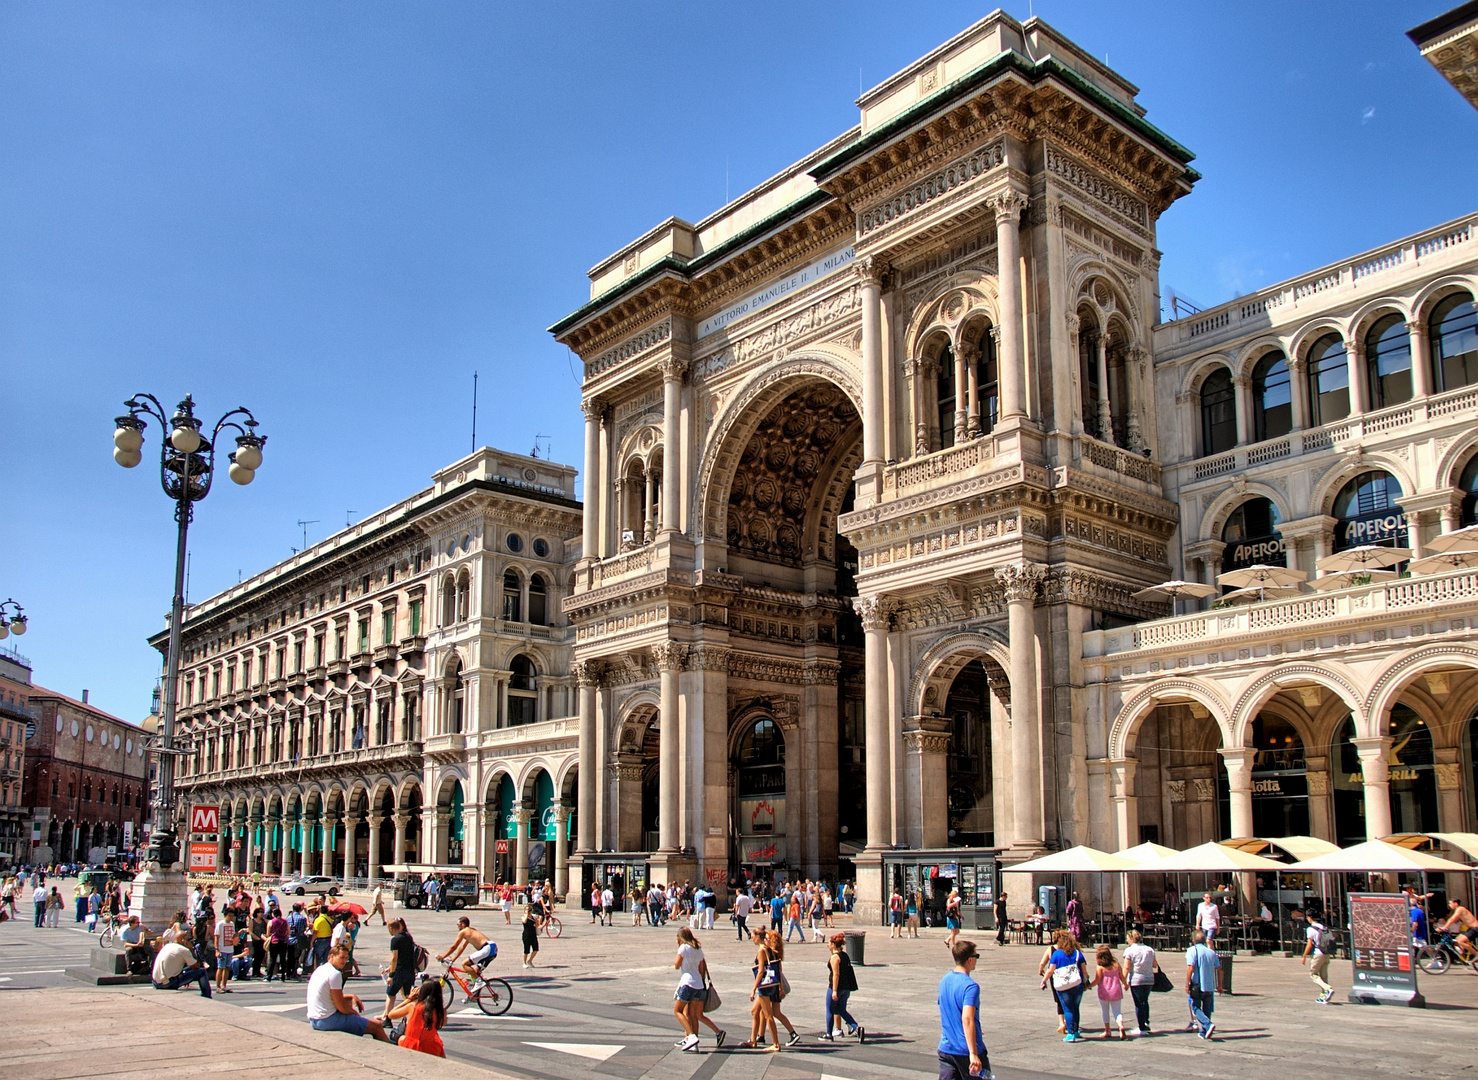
[1156,219,1478,344]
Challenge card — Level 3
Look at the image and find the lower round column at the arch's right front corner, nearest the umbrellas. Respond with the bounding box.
[996,563,1045,851]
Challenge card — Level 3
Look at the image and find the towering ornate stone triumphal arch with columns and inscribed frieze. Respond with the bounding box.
[553,12,1197,925]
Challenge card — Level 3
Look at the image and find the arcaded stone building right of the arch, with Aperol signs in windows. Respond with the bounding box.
[1082,216,1478,904]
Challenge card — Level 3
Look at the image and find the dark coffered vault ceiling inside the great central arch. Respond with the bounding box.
[727,381,862,566]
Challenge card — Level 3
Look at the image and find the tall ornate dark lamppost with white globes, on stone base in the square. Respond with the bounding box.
[112,394,266,925]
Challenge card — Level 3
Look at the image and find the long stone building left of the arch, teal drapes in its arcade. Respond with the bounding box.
[169,448,581,889]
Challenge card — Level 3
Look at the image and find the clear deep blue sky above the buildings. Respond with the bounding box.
[0,0,1478,718]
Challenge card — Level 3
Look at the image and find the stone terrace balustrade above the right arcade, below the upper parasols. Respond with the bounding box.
[1083,570,1478,657]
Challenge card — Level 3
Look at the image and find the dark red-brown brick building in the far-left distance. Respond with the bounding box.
[21,686,149,863]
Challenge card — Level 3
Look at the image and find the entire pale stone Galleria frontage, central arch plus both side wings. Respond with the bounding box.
[175,12,1478,925]
